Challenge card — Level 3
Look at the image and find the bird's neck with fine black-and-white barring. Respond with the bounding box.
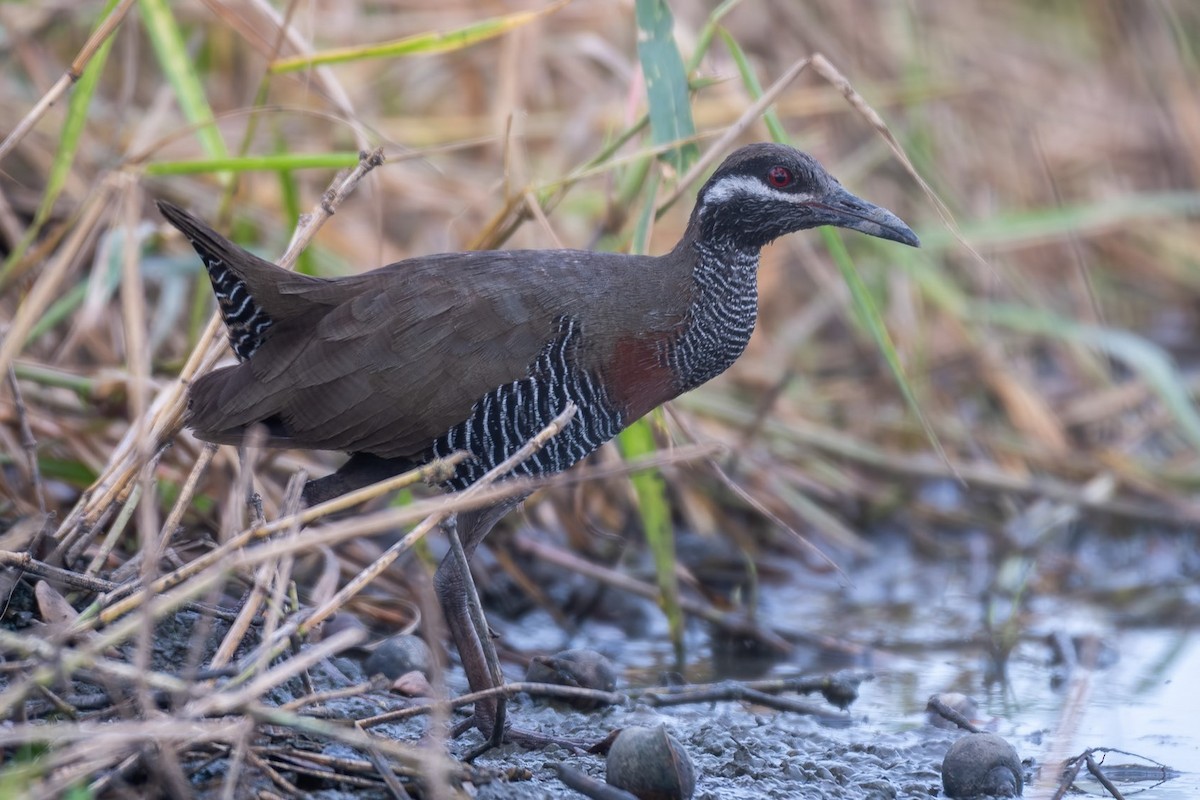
[670,232,758,391]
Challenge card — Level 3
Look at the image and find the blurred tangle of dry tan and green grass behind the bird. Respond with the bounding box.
[0,0,1200,796]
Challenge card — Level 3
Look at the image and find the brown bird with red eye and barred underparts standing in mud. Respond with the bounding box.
[158,143,920,735]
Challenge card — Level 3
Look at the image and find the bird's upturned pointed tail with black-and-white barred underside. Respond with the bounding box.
[158,200,277,361]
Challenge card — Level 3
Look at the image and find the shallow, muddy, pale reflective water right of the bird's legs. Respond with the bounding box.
[477,515,1200,800]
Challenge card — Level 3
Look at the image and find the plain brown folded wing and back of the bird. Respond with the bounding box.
[188,251,678,458]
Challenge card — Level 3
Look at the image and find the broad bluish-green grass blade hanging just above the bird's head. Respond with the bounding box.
[635,0,700,174]
